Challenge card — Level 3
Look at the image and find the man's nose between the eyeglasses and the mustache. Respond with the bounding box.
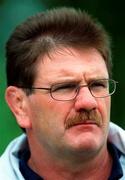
[75,87,97,112]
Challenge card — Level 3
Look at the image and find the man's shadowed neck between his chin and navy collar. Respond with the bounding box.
[28,141,112,180]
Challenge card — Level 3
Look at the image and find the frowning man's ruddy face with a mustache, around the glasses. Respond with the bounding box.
[28,49,110,158]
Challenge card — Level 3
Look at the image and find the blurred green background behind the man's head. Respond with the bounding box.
[0,0,125,154]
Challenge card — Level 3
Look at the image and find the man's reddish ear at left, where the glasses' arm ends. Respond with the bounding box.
[5,86,31,129]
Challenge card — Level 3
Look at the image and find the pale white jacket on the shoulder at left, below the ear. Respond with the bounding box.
[0,134,27,180]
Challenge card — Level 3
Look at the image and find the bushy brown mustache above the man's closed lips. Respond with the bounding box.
[65,110,102,129]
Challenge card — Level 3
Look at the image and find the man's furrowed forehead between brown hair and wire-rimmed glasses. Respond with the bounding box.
[36,48,108,82]
